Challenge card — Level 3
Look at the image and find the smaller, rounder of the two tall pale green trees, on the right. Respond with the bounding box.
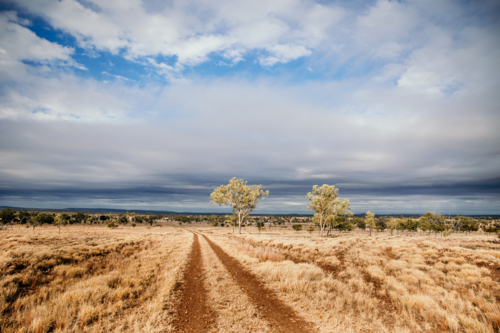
[306,184,349,236]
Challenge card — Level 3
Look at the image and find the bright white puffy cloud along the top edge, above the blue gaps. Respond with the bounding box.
[13,0,343,67]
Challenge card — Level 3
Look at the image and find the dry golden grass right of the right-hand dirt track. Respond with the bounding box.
[205,228,500,332]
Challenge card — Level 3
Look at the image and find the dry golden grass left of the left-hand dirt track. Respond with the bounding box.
[0,227,192,332]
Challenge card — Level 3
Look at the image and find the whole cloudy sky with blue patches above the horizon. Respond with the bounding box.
[0,0,500,214]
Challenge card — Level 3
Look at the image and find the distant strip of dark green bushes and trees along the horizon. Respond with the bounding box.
[0,208,500,233]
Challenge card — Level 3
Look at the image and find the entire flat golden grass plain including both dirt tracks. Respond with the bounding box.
[0,224,500,333]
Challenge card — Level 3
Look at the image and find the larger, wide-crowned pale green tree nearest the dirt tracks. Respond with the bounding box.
[210,177,269,234]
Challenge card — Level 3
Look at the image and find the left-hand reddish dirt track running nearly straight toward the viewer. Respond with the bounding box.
[174,234,216,333]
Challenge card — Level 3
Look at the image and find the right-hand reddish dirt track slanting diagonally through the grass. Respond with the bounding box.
[203,235,312,333]
